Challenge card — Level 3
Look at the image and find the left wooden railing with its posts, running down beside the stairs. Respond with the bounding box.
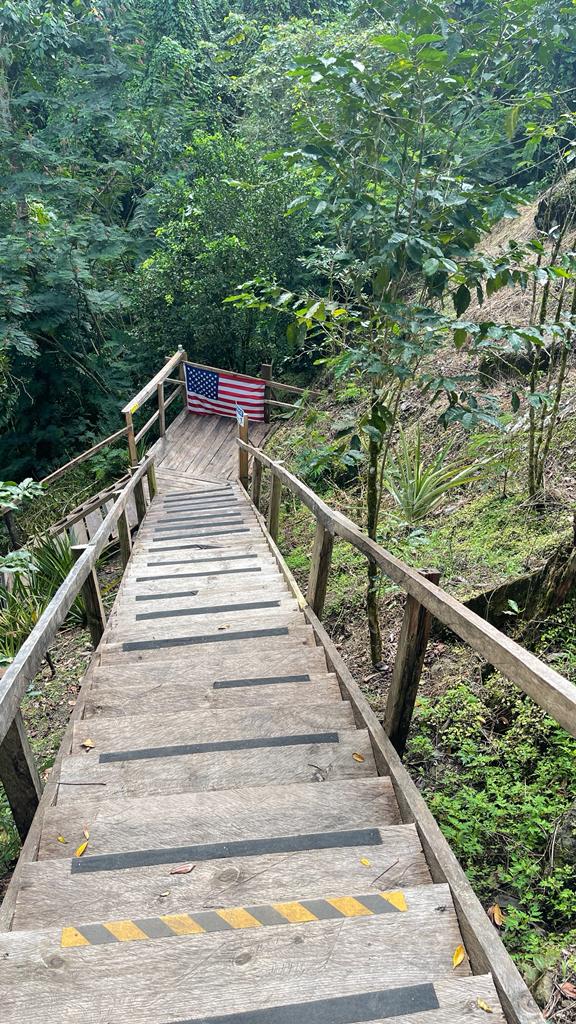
[0,457,157,840]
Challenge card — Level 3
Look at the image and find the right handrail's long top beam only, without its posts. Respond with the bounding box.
[237,438,576,736]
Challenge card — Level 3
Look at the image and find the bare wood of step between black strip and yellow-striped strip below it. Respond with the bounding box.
[12,824,430,930]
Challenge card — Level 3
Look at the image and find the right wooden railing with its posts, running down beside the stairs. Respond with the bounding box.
[238,432,576,755]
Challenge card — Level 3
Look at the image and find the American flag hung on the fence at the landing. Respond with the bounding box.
[184,362,265,420]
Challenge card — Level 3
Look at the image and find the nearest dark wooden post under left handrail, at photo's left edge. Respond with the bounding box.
[0,711,42,843]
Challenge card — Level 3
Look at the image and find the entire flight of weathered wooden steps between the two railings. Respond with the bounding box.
[0,474,504,1024]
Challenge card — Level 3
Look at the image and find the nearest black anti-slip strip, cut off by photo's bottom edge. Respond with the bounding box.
[163,982,440,1024]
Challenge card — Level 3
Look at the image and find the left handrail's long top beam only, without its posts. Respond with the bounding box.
[0,458,154,744]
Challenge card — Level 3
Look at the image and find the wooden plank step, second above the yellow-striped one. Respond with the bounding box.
[38,778,400,864]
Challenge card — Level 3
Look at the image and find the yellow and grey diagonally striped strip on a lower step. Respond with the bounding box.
[60,890,408,948]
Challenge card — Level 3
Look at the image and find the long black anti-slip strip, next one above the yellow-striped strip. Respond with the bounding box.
[71,828,382,874]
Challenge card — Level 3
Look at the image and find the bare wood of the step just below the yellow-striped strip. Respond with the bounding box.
[0,887,471,1024]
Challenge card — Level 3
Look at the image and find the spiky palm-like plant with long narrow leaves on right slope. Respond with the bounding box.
[383,427,491,526]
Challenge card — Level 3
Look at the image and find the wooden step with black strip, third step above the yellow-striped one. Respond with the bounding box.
[57,729,376,808]
